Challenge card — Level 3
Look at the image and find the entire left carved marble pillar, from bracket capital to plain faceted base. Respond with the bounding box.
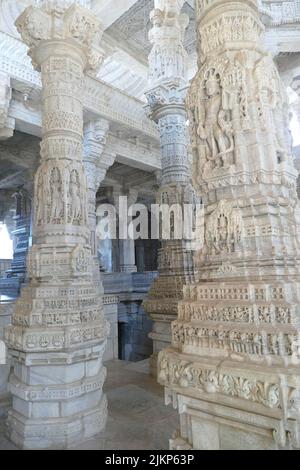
[5,2,108,449]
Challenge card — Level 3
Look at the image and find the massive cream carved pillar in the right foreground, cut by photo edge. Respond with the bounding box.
[159,0,300,449]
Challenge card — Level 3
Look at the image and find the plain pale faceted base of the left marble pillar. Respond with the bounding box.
[6,342,107,449]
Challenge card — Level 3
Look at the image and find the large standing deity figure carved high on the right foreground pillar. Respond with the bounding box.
[197,69,234,170]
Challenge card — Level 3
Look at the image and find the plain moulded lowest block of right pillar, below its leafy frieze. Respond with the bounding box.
[170,395,295,450]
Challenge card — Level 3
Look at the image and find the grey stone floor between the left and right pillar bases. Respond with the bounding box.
[0,361,179,450]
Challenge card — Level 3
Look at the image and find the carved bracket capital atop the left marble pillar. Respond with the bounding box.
[16,2,105,74]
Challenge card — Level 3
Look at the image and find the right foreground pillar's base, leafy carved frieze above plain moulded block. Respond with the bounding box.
[158,348,300,450]
